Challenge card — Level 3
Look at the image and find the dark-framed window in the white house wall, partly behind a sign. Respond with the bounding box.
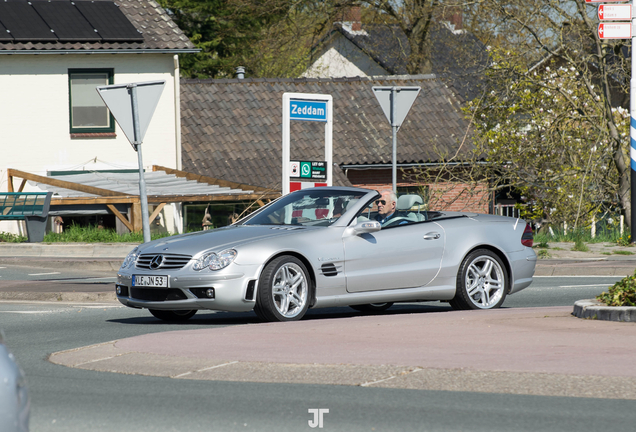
[68,69,115,134]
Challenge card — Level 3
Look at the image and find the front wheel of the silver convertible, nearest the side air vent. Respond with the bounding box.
[254,255,312,322]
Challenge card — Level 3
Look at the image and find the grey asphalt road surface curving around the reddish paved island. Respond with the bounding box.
[0,276,636,432]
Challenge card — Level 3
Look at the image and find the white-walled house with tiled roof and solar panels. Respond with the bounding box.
[0,0,198,233]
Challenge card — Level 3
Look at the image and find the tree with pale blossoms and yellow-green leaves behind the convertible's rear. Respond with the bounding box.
[469,49,629,228]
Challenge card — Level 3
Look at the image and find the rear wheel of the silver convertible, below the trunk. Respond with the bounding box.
[449,249,509,310]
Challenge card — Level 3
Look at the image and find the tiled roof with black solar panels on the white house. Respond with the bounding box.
[0,0,198,54]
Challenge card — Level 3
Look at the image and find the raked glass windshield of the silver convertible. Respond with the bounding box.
[242,189,366,226]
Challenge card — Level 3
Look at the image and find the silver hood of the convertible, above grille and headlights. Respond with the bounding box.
[139,225,311,256]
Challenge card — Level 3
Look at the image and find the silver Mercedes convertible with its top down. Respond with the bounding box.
[116,187,536,321]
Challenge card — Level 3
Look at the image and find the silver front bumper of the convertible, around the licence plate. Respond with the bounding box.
[116,264,260,312]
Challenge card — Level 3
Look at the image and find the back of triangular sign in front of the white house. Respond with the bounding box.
[97,80,166,146]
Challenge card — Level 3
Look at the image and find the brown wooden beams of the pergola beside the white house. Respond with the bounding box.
[7,165,280,232]
